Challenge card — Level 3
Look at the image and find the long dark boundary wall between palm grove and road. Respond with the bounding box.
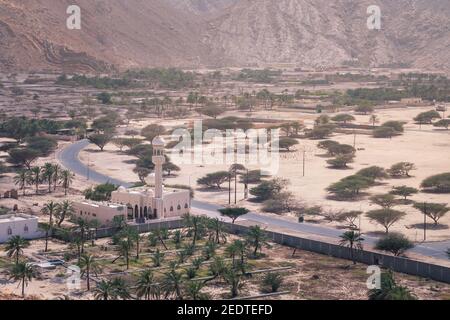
[55,219,450,283]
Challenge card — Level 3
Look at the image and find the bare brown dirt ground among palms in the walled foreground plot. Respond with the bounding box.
[0,235,450,300]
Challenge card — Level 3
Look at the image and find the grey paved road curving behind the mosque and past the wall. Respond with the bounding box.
[57,140,450,259]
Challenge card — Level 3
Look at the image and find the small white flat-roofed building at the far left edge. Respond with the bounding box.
[0,213,41,243]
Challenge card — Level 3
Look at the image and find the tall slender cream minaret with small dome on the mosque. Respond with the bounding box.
[152,136,166,219]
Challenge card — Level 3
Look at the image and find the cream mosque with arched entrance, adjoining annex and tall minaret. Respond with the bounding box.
[73,137,191,226]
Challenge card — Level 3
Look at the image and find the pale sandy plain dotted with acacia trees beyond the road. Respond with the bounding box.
[80,107,450,241]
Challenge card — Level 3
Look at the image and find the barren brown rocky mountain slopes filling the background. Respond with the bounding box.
[0,0,450,71]
